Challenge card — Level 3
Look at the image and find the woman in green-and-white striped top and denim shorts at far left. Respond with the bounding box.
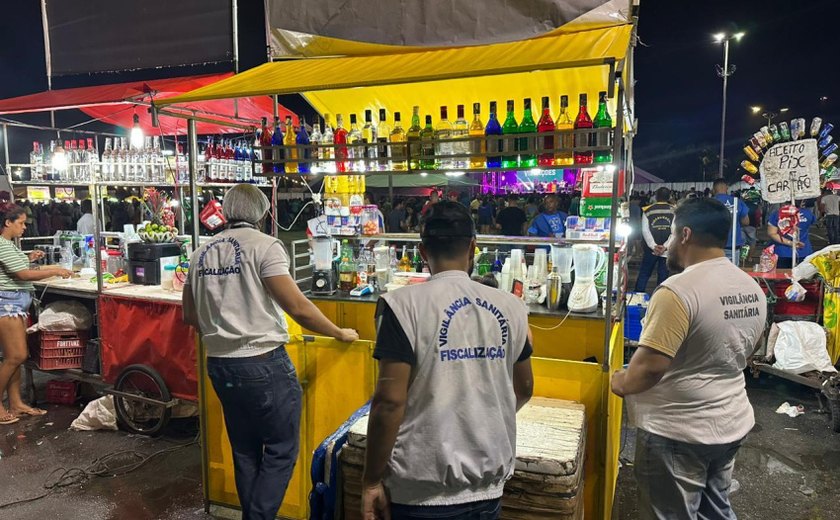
[0,203,73,424]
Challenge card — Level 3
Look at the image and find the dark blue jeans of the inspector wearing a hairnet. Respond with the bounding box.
[207,346,301,520]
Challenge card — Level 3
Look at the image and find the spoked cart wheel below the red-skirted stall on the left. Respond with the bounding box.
[114,365,172,436]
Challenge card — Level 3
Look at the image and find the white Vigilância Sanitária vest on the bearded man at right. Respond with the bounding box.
[627,258,767,445]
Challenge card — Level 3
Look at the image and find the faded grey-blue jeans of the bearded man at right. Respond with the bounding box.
[635,428,743,520]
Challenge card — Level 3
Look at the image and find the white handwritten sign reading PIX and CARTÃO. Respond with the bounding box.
[759,139,820,204]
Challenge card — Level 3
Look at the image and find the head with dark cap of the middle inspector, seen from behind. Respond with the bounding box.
[420,201,475,260]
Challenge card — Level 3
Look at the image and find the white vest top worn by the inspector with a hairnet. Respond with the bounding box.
[185,228,289,358]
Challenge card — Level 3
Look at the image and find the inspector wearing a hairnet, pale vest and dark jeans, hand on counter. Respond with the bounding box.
[183,184,358,520]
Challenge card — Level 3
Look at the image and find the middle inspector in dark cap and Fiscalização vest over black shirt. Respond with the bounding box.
[362,202,533,520]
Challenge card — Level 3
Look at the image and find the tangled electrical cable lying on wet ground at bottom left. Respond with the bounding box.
[0,437,198,509]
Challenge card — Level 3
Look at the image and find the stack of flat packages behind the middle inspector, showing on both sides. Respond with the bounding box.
[339,398,586,520]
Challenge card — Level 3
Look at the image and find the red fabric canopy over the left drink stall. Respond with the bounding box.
[0,73,298,135]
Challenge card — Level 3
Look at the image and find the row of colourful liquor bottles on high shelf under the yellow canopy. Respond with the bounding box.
[259,92,612,174]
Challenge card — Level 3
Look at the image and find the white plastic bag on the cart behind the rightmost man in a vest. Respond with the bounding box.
[768,321,837,374]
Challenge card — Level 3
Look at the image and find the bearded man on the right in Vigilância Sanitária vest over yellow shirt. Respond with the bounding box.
[612,198,767,520]
